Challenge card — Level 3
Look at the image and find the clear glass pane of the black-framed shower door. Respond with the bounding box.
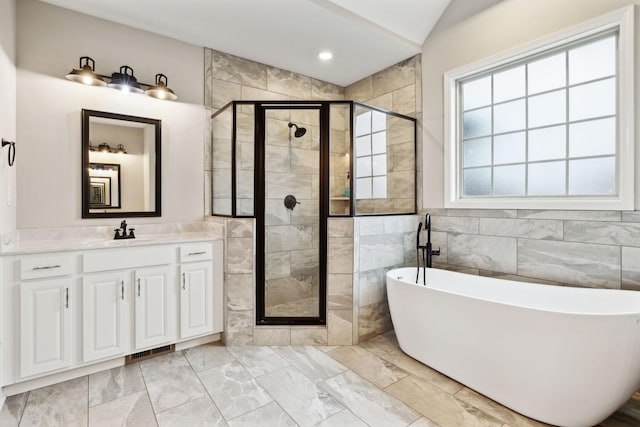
[258,107,325,323]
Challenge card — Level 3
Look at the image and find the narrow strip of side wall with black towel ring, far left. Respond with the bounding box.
[0,0,16,236]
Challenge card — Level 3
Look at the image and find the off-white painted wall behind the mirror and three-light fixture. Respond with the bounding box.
[16,0,206,228]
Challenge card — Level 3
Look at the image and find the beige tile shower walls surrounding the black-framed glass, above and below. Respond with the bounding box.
[205,49,422,345]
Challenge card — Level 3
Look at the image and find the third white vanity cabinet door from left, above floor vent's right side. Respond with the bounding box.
[134,266,175,349]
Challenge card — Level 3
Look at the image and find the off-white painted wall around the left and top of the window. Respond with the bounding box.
[422,0,640,208]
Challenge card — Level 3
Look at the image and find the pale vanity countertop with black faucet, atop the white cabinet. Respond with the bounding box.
[0,231,222,256]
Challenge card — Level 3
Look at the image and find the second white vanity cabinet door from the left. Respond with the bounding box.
[82,272,130,362]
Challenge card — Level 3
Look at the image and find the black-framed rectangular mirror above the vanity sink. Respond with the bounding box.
[82,109,162,218]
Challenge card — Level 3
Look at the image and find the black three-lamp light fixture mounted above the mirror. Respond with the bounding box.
[66,56,178,101]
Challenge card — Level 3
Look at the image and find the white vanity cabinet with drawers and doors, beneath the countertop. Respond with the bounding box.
[0,238,223,393]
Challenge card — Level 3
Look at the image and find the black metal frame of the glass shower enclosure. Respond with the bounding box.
[211,100,418,326]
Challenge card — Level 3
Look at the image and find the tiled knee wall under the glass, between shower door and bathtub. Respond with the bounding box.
[327,215,418,345]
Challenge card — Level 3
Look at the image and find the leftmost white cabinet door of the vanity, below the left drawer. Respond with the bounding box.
[19,278,73,377]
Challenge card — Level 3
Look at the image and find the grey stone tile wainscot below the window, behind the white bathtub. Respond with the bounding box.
[425,209,640,290]
